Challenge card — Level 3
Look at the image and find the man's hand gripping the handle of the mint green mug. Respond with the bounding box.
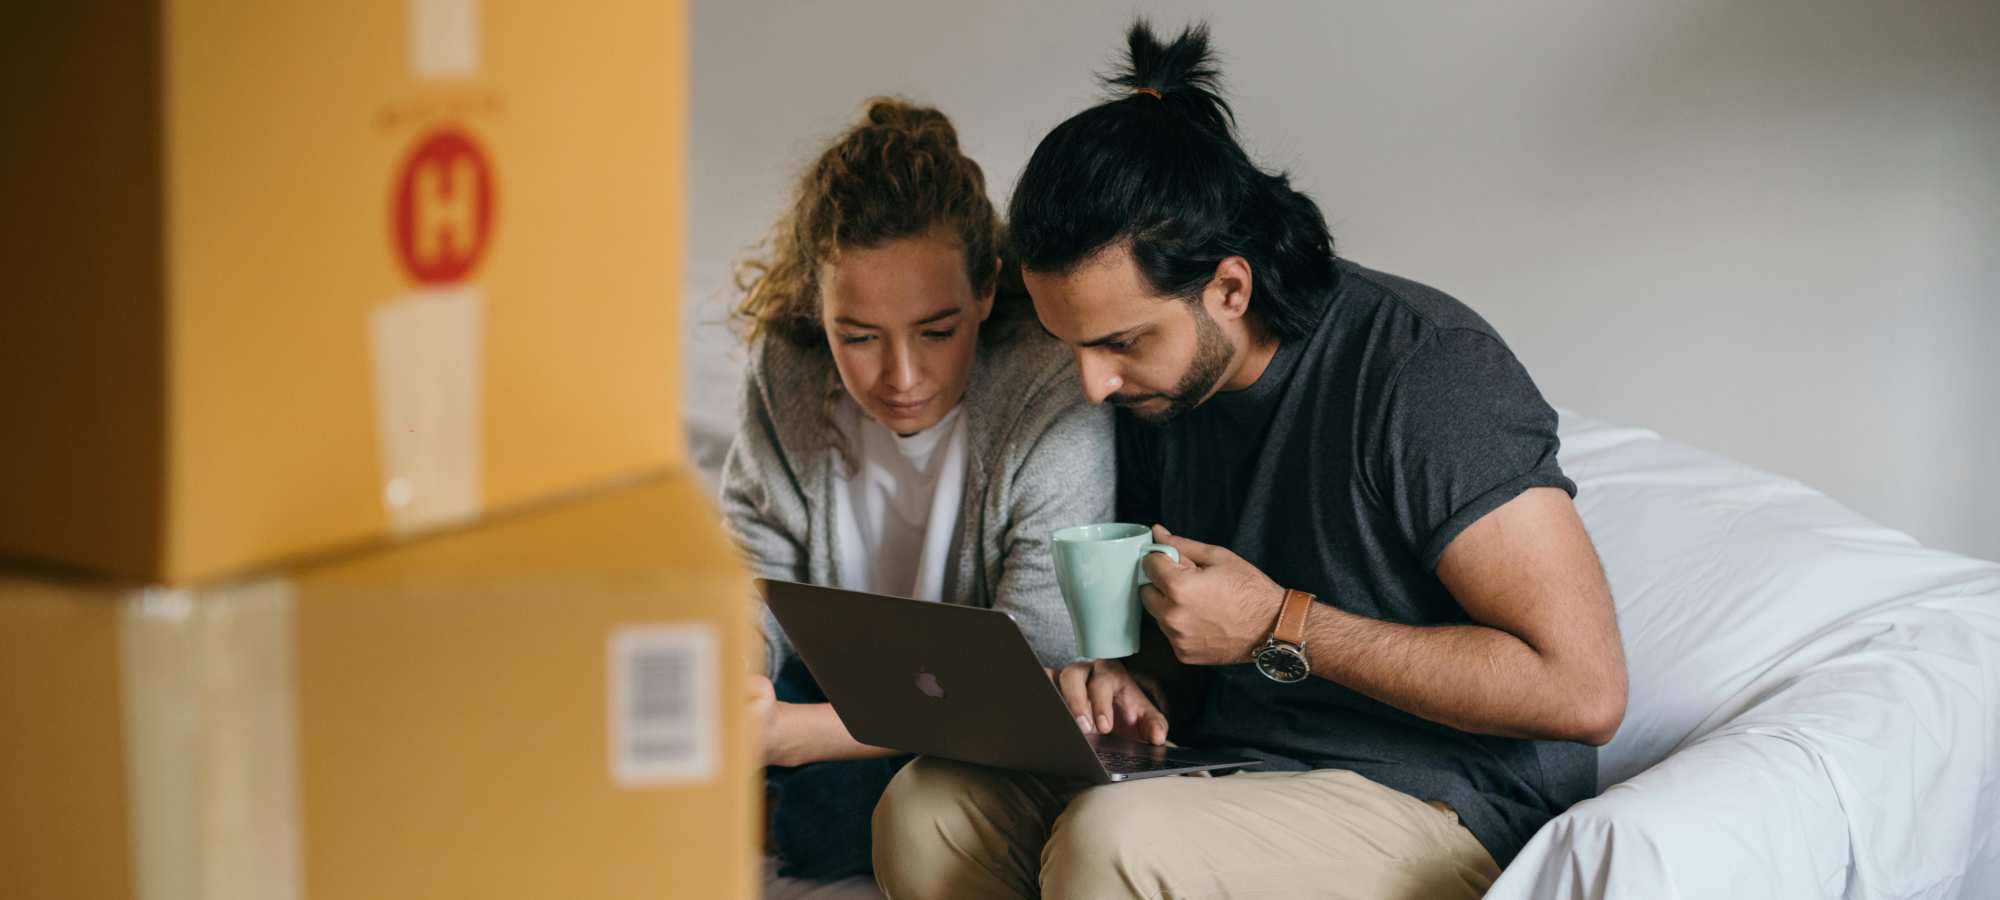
[1138,526,1284,666]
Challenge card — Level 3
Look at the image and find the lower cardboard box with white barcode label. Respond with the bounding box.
[0,476,762,900]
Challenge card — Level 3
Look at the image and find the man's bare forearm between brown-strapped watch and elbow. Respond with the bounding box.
[1306,606,1622,744]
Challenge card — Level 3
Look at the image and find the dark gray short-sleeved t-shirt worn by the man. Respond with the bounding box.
[1118,260,1596,866]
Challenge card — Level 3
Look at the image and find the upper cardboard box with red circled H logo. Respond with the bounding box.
[0,0,688,584]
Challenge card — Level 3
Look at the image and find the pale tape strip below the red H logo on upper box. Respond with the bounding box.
[372,286,486,534]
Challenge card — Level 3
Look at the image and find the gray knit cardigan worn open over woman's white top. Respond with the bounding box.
[722,326,1116,676]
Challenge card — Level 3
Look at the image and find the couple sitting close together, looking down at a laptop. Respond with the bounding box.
[724,22,1626,898]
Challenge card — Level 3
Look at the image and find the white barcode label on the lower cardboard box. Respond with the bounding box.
[610,624,720,786]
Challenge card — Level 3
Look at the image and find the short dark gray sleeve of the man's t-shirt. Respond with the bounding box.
[1362,328,1576,568]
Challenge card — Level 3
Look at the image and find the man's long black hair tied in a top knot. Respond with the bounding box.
[1008,20,1336,338]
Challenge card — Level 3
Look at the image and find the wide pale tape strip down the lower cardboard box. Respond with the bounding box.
[118,578,304,900]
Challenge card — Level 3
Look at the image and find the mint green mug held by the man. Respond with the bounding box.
[1054,522,1180,660]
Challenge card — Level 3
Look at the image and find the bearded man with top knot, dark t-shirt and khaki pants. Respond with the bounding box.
[874,22,1626,898]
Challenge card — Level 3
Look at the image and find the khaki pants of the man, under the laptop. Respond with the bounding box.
[874,758,1500,900]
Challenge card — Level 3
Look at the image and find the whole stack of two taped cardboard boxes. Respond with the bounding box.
[0,0,756,900]
